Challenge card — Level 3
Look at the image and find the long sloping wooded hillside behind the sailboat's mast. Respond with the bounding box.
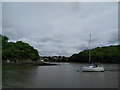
[69,45,120,63]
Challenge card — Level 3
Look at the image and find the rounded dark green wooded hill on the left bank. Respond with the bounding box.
[0,35,40,62]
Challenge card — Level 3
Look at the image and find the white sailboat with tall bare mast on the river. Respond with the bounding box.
[82,34,104,72]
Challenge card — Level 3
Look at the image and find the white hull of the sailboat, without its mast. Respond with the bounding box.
[82,66,104,72]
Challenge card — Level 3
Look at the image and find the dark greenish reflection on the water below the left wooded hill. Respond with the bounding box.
[3,66,37,88]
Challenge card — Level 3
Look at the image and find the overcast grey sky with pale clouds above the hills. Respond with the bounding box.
[2,2,118,56]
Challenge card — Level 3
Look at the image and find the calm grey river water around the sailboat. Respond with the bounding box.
[2,63,118,88]
